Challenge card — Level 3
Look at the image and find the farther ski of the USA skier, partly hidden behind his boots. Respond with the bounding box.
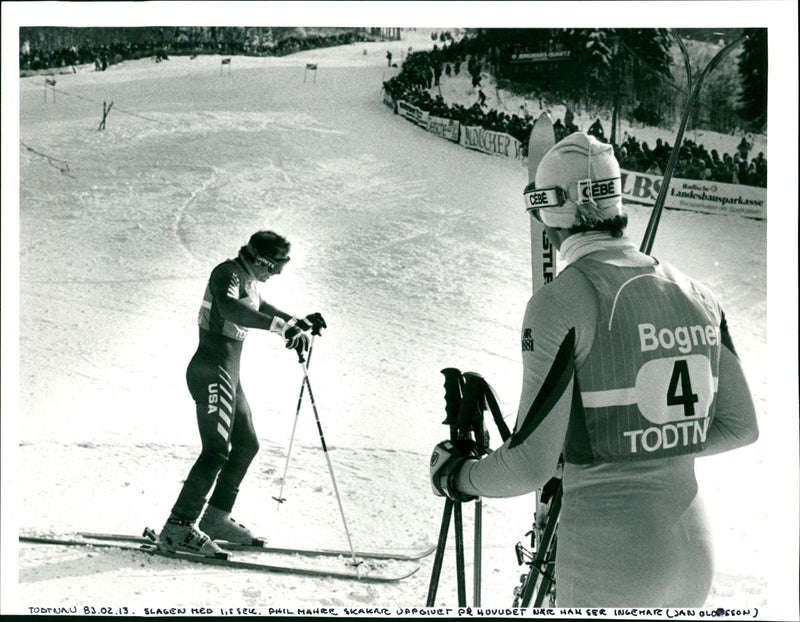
[73,529,436,561]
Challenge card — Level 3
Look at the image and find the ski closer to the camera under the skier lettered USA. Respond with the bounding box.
[19,536,419,583]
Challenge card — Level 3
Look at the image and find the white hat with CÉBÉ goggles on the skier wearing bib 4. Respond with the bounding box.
[525,132,622,229]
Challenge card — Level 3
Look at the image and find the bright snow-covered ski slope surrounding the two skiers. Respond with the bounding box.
[2,22,796,615]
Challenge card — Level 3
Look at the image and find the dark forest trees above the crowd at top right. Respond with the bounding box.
[470,28,767,133]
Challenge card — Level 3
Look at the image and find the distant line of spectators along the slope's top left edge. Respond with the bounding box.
[19,28,374,71]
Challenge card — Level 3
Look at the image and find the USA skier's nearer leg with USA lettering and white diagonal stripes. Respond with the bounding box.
[172,349,239,522]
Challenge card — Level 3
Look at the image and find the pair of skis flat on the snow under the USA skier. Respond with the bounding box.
[19,529,434,583]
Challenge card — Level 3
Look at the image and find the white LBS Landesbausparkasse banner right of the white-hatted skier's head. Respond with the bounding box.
[621,170,767,219]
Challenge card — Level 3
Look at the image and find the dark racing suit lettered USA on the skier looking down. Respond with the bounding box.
[172,258,261,521]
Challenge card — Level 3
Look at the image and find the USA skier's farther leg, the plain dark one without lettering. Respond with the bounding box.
[208,384,258,512]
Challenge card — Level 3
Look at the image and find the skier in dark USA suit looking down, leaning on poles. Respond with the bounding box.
[159,231,325,555]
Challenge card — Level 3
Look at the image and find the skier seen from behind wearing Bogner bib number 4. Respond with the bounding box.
[431,133,758,607]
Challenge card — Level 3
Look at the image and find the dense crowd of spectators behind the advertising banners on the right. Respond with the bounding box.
[383,44,767,188]
